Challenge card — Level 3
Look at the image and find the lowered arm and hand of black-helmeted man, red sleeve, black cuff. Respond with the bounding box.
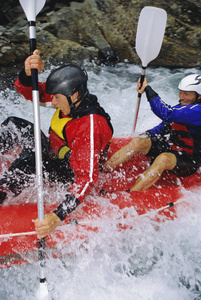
[35,115,112,238]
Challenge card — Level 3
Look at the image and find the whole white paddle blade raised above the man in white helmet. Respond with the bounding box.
[136,6,167,67]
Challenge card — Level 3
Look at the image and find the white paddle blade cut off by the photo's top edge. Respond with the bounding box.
[19,0,46,21]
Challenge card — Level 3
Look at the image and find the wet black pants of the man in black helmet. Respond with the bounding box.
[0,117,73,195]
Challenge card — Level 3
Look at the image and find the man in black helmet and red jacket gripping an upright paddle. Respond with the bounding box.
[0,50,113,238]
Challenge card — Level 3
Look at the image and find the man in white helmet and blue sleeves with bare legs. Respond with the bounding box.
[104,74,201,191]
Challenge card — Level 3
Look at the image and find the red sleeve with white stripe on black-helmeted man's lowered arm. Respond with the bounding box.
[69,115,102,202]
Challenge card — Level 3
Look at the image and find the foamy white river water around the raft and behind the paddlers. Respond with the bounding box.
[0,64,201,300]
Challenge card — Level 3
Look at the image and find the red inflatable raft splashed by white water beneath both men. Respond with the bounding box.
[0,137,201,268]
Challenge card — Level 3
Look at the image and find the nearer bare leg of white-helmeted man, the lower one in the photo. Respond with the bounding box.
[130,152,177,191]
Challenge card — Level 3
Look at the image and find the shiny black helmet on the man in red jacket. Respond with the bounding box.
[46,64,88,97]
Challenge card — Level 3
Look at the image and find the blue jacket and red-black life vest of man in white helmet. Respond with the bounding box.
[145,86,201,164]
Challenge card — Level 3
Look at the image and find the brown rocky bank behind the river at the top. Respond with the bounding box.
[0,0,201,83]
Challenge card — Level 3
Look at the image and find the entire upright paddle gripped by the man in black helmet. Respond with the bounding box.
[19,0,49,300]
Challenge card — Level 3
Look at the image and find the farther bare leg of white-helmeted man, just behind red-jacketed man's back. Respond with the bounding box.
[103,137,151,172]
